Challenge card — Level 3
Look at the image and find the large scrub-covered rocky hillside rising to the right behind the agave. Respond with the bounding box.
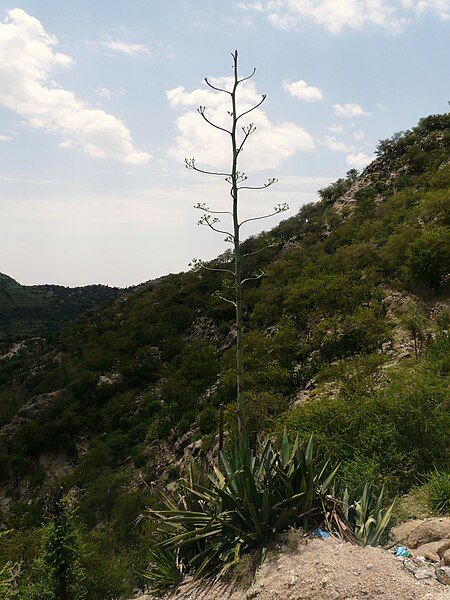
[0,114,450,599]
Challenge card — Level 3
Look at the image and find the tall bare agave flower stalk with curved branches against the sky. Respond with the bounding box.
[185,50,288,432]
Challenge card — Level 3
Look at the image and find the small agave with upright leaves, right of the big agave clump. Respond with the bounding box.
[342,482,394,546]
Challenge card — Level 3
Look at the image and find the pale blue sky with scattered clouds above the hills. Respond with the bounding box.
[0,0,450,287]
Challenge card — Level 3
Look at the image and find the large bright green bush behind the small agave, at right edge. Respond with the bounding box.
[282,338,449,494]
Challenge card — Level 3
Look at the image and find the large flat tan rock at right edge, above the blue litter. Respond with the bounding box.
[391,517,450,549]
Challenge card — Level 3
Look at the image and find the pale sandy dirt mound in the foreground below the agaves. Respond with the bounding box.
[139,538,450,600]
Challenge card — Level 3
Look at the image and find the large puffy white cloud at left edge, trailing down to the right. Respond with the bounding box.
[0,8,150,165]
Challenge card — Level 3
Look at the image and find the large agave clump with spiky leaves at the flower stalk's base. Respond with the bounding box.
[147,432,337,588]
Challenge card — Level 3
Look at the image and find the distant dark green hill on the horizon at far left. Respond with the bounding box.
[0,273,124,341]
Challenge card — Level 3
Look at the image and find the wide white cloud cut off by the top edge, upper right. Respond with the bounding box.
[238,0,450,34]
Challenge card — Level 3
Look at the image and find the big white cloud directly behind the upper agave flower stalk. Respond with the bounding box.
[167,77,314,171]
